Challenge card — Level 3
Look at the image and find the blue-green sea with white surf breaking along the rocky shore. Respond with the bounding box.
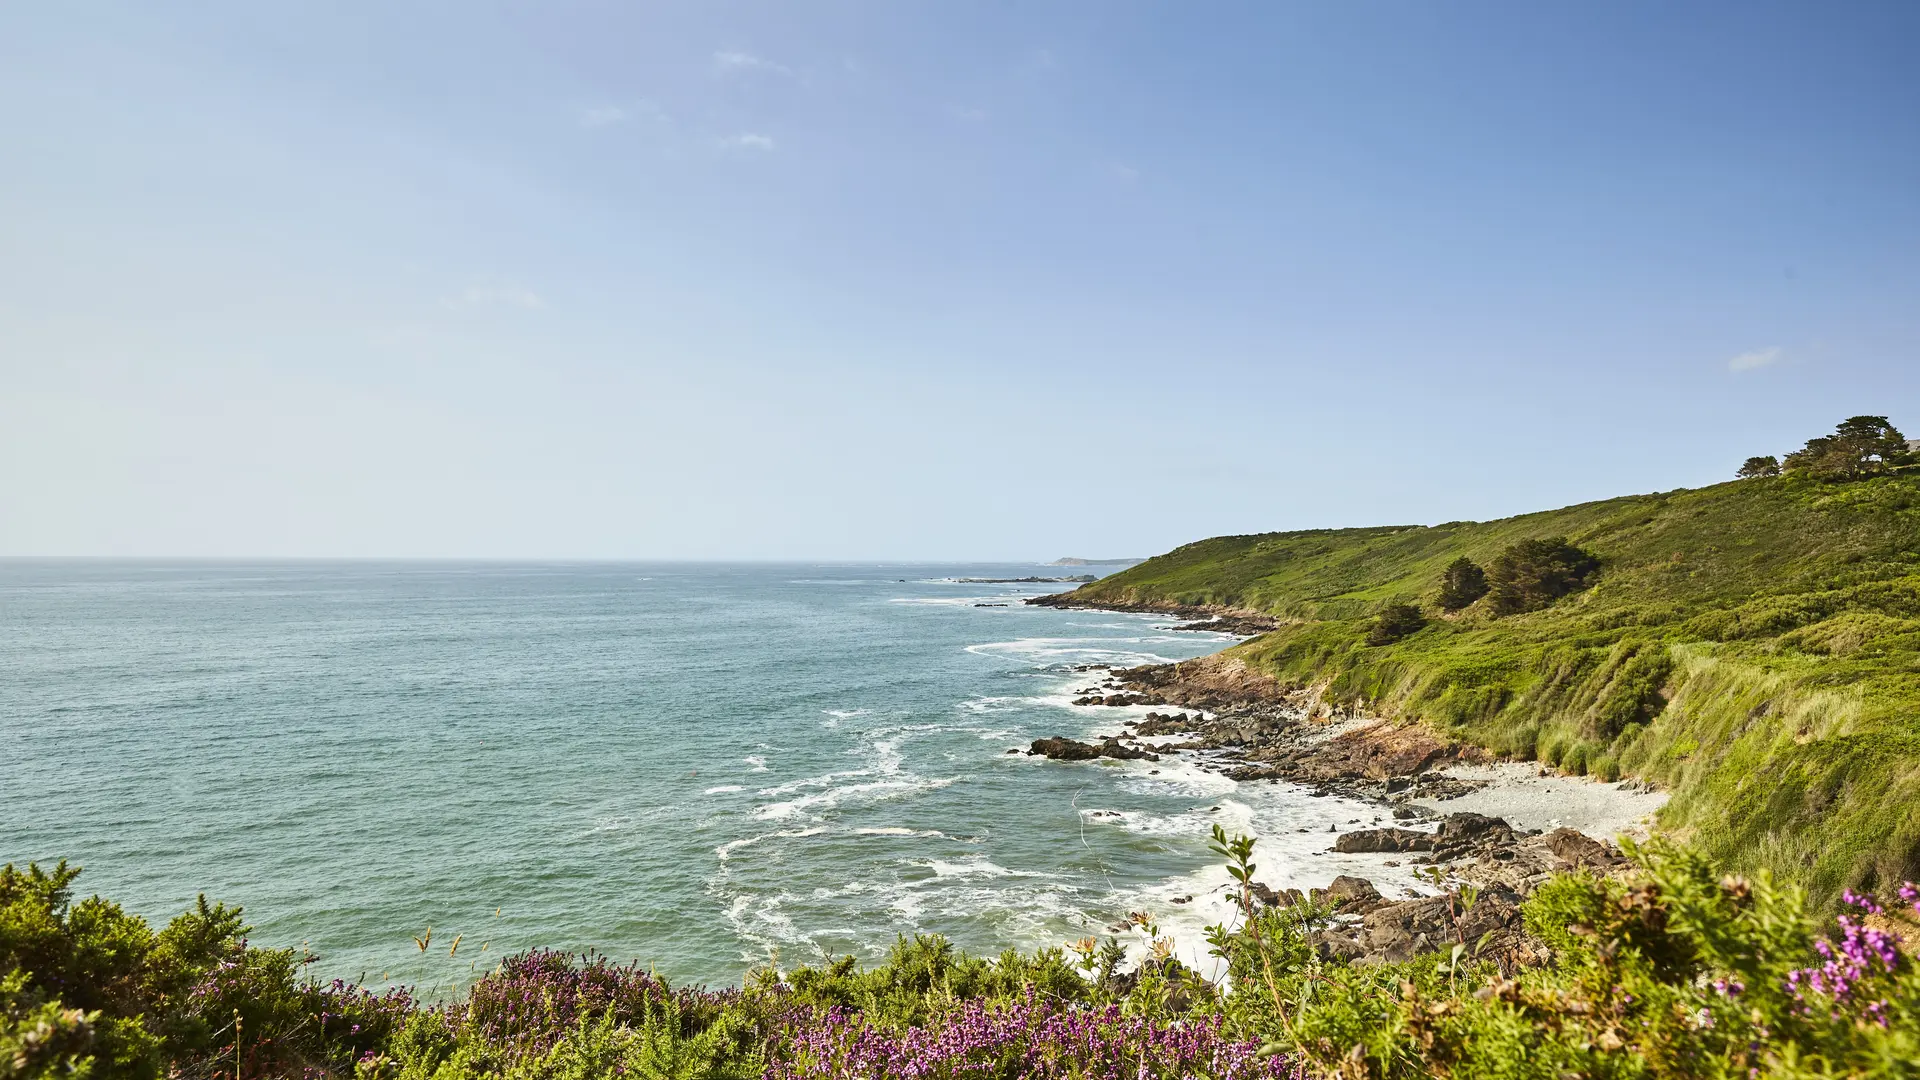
[0,559,1413,997]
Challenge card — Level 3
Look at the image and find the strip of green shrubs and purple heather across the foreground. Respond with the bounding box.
[0,836,1920,1080]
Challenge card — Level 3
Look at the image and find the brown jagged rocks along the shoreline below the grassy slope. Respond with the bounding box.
[1014,596,1658,965]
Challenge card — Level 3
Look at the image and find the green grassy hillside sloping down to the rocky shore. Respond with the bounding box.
[1075,471,1920,899]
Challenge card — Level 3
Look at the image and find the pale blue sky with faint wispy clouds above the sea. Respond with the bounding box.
[0,0,1920,559]
